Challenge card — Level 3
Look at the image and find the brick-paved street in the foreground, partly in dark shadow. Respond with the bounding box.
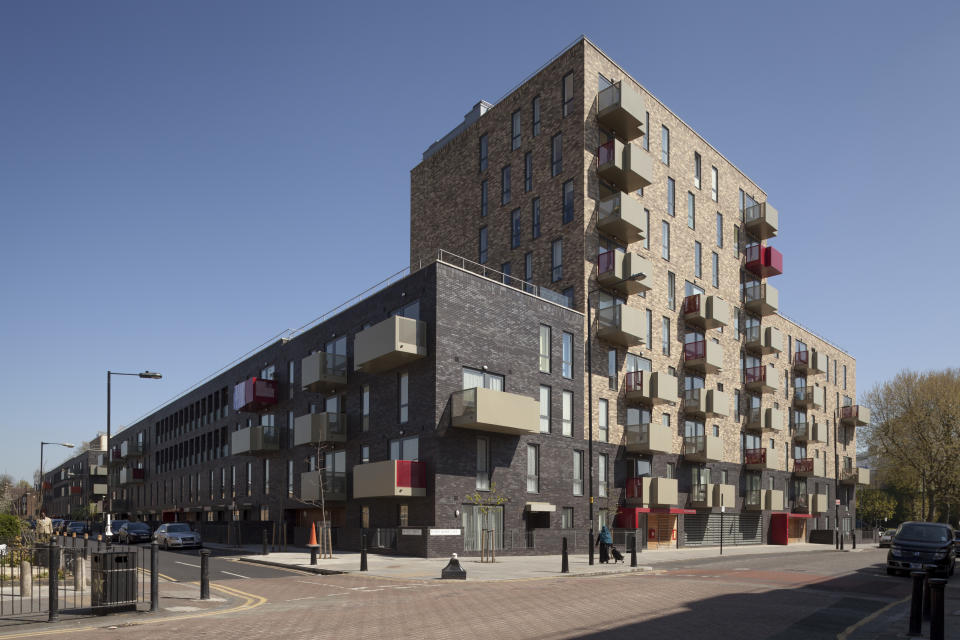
[13,547,928,640]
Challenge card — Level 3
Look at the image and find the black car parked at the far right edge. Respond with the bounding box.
[887,522,957,577]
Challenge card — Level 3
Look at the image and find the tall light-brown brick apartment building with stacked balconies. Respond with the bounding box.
[410,38,869,545]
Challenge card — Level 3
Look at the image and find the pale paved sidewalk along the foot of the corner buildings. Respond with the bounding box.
[225,544,848,580]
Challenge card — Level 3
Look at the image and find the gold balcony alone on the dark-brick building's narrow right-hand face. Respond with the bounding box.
[450,387,540,435]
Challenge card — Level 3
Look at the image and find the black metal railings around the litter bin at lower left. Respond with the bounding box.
[0,536,152,626]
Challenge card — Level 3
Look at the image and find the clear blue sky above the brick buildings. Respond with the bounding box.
[0,0,960,477]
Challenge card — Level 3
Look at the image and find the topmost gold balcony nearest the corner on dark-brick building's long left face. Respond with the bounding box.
[353,316,427,373]
